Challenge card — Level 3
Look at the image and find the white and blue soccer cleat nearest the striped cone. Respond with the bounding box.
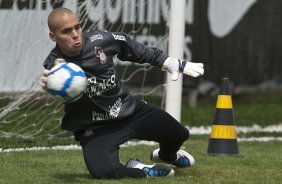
[150,149,195,167]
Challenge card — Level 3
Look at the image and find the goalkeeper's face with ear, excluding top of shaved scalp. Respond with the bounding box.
[49,14,82,57]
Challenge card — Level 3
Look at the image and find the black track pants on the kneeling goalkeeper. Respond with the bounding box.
[80,100,189,179]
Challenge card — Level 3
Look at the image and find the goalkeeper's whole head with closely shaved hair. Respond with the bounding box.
[48,8,82,57]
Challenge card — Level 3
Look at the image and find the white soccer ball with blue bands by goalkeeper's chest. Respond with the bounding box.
[47,63,87,102]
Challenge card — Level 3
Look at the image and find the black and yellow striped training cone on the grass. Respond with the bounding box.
[207,78,239,156]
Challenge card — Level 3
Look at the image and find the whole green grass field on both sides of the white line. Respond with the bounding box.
[0,91,282,184]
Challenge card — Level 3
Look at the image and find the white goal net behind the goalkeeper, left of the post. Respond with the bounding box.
[0,0,192,138]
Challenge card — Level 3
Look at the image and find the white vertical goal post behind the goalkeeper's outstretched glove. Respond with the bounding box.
[165,0,186,121]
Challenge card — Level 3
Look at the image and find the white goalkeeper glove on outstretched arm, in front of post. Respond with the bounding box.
[162,57,204,81]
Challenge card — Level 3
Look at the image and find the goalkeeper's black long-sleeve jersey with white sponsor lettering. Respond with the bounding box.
[43,30,168,132]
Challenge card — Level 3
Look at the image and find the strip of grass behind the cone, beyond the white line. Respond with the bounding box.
[182,100,282,126]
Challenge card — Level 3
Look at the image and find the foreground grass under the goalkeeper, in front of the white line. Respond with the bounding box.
[0,136,282,184]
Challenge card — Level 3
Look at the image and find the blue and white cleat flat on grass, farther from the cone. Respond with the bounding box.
[125,159,174,176]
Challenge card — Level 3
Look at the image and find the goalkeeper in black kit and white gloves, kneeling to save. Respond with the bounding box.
[40,8,204,179]
